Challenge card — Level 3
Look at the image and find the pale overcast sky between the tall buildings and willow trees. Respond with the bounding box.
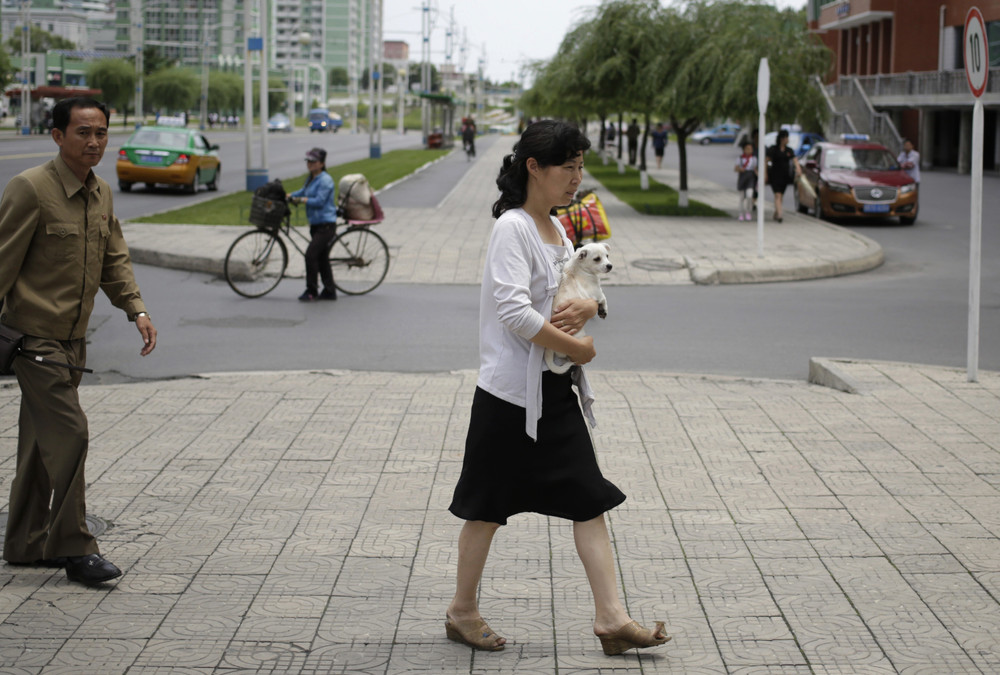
[383,0,806,82]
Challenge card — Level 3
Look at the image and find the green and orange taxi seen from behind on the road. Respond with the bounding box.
[115,126,222,193]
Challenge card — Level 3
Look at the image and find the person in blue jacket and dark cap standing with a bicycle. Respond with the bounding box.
[286,148,337,302]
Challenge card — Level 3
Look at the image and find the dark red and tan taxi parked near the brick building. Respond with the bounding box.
[792,140,919,225]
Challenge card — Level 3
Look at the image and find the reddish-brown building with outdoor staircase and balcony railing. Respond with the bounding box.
[807,0,1000,172]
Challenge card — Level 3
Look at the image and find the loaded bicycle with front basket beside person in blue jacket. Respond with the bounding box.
[223,195,389,298]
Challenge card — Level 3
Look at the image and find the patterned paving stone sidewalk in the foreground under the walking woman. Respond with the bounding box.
[0,362,1000,674]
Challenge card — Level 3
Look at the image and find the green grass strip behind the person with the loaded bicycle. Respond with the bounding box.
[132,150,450,225]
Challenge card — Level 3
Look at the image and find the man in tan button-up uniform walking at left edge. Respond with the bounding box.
[0,98,156,584]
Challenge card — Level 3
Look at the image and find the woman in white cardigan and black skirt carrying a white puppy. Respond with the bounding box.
[445,120,670,655]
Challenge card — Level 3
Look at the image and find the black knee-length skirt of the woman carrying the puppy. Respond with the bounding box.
[449,371,625,525]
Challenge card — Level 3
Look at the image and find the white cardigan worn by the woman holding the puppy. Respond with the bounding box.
[477,209,597,440]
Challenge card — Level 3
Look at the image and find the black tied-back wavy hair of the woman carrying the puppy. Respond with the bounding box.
[493,120,590,218]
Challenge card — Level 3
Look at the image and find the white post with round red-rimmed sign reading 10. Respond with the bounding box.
[962,7,990,382]
